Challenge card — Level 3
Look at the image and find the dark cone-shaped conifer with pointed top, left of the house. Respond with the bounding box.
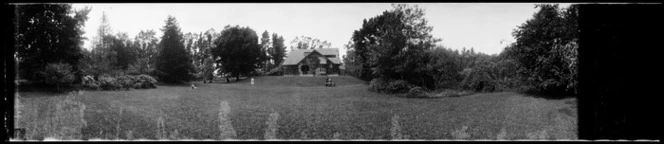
[156,16,194,83]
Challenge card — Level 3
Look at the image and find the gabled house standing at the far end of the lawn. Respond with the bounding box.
[281,48,341,75]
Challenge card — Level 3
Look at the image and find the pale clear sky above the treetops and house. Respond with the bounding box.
[72,3,569,55]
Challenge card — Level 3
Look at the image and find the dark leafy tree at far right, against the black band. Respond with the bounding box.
[505,5,579,93]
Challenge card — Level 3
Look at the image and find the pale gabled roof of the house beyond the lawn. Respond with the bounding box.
[281,48,341,65]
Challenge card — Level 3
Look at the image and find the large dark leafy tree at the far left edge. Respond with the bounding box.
[12,4,91,80]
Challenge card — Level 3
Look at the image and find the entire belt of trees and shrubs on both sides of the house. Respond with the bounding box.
[13,4,578,93]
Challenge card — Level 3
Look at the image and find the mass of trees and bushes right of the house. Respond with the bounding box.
[343,4,578,94]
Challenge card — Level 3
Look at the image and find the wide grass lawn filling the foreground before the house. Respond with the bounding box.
[16,76,577,140]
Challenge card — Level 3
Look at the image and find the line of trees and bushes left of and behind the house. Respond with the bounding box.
[13,4,330,89]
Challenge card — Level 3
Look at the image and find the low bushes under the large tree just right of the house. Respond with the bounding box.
[369,78,413,93]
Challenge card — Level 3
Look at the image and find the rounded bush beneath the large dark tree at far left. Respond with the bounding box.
[42,63,76,90]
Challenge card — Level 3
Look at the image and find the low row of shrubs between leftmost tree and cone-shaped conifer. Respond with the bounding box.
[83,75,157,90]
